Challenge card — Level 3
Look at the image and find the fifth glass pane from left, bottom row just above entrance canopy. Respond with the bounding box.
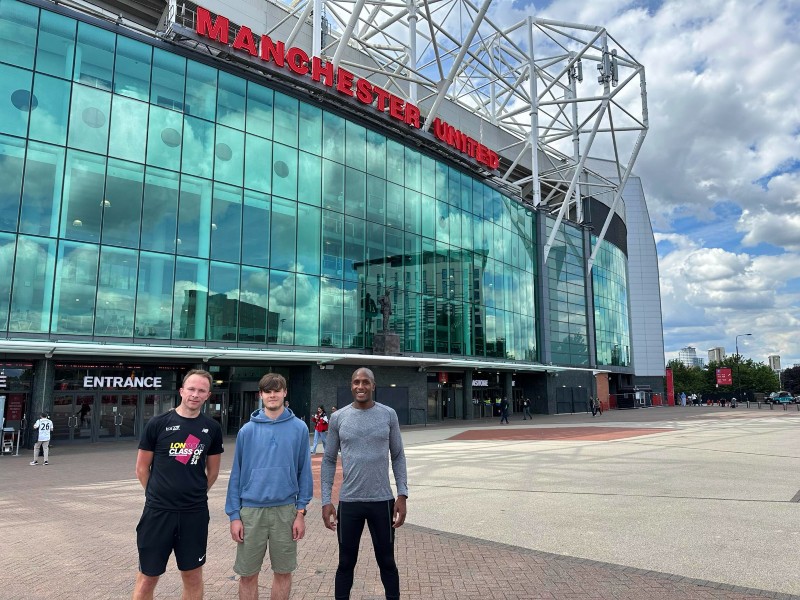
[134,252,174,339]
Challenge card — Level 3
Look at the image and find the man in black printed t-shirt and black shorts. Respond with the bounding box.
[133,370,223,600]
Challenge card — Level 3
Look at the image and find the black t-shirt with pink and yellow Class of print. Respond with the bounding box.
[139,410,223,511]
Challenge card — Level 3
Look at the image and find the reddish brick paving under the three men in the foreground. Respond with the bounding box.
[0,418,796,600]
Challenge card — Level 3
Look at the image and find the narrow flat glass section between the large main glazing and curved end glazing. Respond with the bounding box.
[546,217,589,366]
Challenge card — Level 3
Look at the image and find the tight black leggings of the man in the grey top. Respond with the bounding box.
[334,500,400,600]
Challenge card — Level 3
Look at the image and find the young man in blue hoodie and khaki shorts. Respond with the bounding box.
[225,373,314,600]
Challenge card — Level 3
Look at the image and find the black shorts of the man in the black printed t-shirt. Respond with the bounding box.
[136,506,209,577]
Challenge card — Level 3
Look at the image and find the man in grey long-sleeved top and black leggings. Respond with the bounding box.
[321,368,408,600]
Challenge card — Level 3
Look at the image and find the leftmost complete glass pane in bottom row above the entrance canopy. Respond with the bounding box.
[9,236,56,333]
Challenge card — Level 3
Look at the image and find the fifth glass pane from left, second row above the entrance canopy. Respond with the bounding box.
[141,167,178,254]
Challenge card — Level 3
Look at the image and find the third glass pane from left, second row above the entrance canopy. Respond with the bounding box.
[61,150,106,242]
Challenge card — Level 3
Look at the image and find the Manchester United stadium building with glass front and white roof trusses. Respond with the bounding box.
[0,0,664,441]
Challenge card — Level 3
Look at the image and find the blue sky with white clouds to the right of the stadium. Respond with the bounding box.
[493,0,800,368]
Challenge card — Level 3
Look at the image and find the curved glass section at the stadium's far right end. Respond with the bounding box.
[592,236,631,367]
